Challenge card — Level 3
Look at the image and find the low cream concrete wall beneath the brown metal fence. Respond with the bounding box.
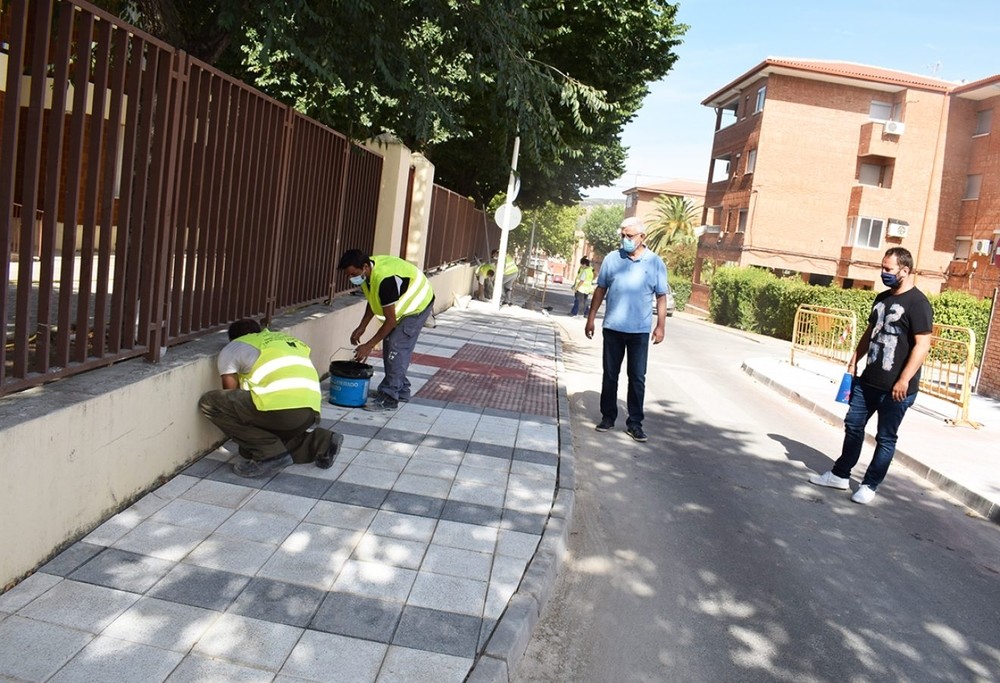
[0,264,472,589]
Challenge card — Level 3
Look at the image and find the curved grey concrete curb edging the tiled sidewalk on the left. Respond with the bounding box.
[465,328,576,683]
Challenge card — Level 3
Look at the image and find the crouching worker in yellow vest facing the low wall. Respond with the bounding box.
[198,319,344,477]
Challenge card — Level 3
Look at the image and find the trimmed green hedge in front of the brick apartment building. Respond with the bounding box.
[712,266,992,364]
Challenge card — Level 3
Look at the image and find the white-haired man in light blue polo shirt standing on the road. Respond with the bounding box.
[584,217,667,441]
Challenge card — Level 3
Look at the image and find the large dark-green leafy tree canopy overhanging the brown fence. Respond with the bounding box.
[99,0,687,206]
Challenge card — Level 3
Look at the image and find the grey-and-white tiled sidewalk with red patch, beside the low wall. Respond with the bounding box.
[0,303,573,683]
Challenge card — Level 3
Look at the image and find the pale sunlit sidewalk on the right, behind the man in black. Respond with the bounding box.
[743,353,1000,523]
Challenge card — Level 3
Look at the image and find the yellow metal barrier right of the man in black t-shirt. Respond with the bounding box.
[920,325,981,429]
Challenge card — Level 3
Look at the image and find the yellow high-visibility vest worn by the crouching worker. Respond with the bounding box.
[238,330,323,413]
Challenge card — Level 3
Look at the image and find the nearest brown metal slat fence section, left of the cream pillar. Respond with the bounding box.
[0,0,384,394]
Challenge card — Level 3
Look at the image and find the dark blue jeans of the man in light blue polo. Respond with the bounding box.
[601,328,649,427]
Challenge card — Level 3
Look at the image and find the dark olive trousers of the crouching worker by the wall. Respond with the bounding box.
[198,389,333,463]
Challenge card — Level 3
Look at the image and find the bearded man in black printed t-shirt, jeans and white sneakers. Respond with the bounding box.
[809,247,934,505]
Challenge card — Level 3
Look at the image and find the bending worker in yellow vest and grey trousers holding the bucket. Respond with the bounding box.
[337,249,434,411]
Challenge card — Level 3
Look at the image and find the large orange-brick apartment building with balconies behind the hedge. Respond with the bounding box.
[695,58,1000,296]
